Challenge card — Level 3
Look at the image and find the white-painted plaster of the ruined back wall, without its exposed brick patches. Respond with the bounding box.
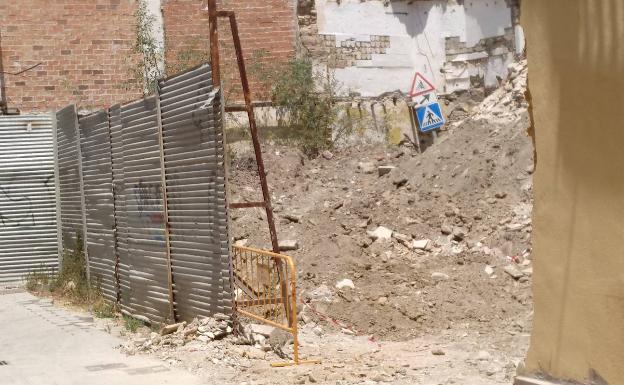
[316,0,513,96]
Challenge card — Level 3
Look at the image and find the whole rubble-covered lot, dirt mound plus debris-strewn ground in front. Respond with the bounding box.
[13,61,534,385]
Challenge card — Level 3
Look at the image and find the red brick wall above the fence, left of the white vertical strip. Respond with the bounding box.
[0,0,140,112]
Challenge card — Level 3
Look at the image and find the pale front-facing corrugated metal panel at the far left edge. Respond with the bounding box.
[0,115,58,285]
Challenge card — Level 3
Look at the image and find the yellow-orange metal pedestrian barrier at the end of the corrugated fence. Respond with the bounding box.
[232,246,320,367]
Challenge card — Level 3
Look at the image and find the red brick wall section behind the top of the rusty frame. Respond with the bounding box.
[162,0,296,102]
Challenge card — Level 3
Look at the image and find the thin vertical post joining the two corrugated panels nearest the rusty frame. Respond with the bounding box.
[155,82,178,322]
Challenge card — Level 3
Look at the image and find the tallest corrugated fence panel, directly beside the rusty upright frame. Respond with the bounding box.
[159,65,232,320]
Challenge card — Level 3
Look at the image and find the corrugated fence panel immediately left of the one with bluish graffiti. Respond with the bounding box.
[79,111,117,301]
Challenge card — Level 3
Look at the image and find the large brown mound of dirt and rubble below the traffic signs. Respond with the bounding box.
[231,59,533,339]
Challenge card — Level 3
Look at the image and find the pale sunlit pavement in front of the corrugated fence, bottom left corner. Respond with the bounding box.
[0,291,200,385]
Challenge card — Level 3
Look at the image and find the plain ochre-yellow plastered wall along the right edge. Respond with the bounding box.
[522,0,624,385]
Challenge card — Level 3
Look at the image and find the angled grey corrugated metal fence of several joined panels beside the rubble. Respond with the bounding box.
[57,65,232,323]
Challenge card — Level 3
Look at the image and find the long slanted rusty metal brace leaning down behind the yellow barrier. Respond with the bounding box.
[216,9,297,325]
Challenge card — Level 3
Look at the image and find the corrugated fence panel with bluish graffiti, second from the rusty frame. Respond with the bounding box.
[121,97,170,322]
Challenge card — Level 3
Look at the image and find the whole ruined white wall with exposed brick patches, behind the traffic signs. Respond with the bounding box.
[302,0,515,96]
